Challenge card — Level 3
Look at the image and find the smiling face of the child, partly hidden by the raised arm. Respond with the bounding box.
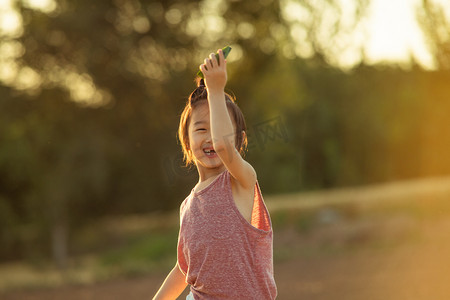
[188,101,234,169]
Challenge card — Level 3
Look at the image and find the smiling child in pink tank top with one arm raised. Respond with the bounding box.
[153,50,277,300]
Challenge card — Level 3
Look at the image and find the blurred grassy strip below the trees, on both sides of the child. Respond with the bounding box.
[0,176,450,292]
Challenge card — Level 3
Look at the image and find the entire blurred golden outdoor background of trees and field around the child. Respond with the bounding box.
[0,0,450,299]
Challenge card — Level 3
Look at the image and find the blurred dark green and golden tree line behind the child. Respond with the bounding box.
[0,0,450,261]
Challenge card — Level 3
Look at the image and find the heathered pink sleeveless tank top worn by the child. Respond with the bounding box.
[178,170,277,300]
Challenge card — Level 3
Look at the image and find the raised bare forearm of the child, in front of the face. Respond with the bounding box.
[208,89,235,152]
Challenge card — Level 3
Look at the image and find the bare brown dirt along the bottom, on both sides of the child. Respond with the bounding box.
[0,218,450,300]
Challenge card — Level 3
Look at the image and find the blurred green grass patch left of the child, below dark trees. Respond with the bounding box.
[0,224,178,292]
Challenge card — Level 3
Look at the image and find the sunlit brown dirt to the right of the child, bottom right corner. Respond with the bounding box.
[276,219,450,300]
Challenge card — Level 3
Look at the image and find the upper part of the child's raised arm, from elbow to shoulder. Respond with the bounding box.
[214,145,256,189]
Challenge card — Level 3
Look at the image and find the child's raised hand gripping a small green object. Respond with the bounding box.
[200,49,227,93]
